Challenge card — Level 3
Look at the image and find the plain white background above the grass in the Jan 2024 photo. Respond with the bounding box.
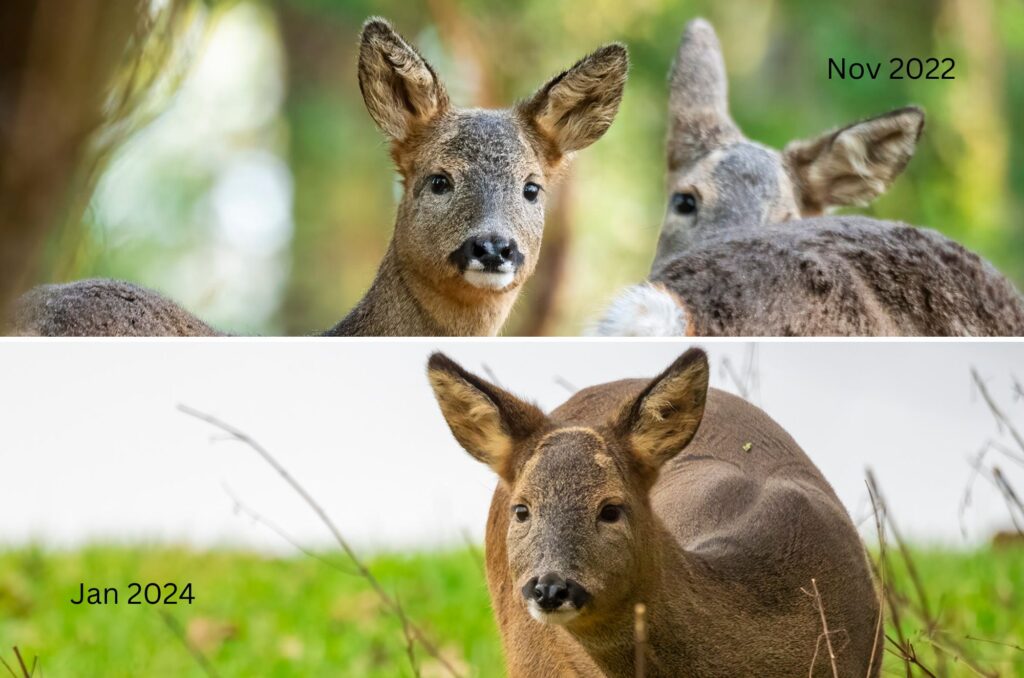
[0,339,1024,551]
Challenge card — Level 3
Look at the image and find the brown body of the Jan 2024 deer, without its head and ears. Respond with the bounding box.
[486,387,882,678]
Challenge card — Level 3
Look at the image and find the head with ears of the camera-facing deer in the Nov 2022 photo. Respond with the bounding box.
[358,18,629,303]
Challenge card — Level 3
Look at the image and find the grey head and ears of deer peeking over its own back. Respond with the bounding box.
[655,19,925,268]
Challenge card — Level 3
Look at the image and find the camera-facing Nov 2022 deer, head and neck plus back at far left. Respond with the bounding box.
[13,18,629,335]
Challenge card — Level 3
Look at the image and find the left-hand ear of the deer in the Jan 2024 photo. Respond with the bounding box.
[427,353,547,480]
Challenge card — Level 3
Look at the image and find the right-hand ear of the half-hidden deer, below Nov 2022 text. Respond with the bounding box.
[782,107,925,215]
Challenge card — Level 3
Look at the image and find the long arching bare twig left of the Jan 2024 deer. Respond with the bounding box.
[178,405,459,678]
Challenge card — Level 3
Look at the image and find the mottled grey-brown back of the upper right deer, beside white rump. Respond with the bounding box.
[650,216,1024,336]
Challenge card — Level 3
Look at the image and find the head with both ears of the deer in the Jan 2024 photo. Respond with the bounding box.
[428,349,709,630]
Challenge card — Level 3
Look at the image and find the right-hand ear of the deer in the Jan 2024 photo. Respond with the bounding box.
[624,348,709,470]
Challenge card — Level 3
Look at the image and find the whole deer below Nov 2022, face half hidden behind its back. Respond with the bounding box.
[595,19,1024,336]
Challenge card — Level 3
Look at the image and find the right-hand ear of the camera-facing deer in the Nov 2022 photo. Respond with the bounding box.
[516,43,630,160]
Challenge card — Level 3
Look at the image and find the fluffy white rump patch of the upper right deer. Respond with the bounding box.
[587,283,687,337]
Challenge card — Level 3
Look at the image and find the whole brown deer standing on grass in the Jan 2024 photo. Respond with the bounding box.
[428,348,882,678]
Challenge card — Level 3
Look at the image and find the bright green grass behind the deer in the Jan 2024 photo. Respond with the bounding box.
[0,546,1024,678]
